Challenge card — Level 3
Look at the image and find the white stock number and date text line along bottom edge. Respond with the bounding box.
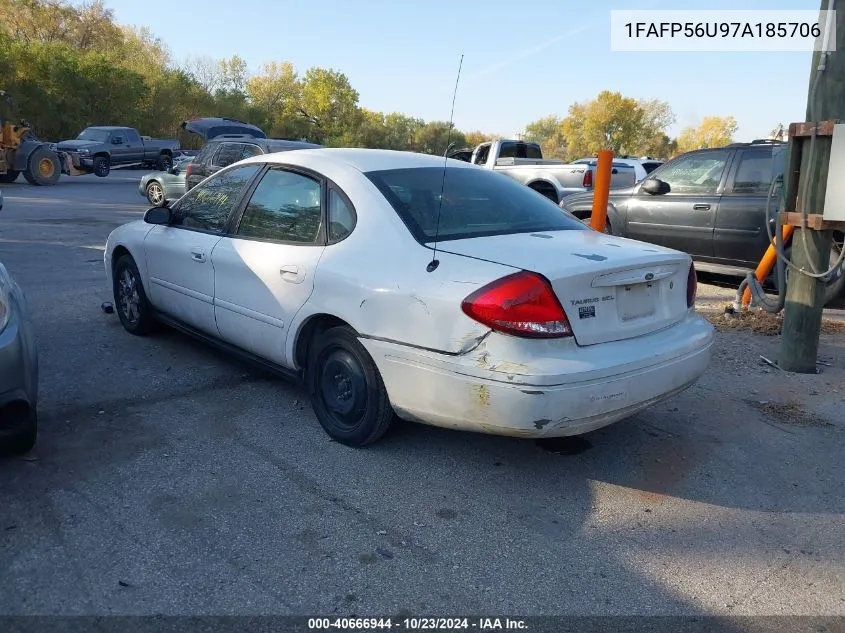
[308,617,528,631]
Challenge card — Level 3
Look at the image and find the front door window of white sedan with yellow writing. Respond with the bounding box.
[173,165,261,233]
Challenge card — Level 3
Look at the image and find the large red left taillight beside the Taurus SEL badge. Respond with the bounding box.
[461,271,572,338]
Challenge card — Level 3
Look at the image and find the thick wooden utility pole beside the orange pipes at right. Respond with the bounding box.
[778,0,845,374]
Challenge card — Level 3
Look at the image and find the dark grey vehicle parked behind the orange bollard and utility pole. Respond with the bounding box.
[560,140,845,302]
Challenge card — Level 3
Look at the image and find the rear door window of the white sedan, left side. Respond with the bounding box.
[237,167,322,244]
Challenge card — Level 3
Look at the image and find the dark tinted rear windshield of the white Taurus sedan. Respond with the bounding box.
[366,167,587,244]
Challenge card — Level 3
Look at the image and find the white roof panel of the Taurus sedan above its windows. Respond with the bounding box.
[242,147,474,173]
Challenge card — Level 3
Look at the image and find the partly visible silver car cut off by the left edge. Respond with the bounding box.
[0,193,38,455]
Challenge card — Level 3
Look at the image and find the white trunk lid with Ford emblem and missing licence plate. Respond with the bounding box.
[438,230,690,345]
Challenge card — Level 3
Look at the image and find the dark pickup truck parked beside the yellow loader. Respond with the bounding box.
[56,125,180,177]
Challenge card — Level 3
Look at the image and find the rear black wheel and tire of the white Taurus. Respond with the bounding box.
[305,326,394,447]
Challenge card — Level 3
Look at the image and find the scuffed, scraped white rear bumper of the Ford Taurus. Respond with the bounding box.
[362,314,714,437]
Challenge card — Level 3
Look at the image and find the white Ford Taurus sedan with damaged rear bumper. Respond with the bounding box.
[105,149,714,446]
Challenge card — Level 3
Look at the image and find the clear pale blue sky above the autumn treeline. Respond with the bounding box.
[99,0,820,140]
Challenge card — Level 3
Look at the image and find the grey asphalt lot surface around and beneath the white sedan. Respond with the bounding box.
[0,171,845,616]
